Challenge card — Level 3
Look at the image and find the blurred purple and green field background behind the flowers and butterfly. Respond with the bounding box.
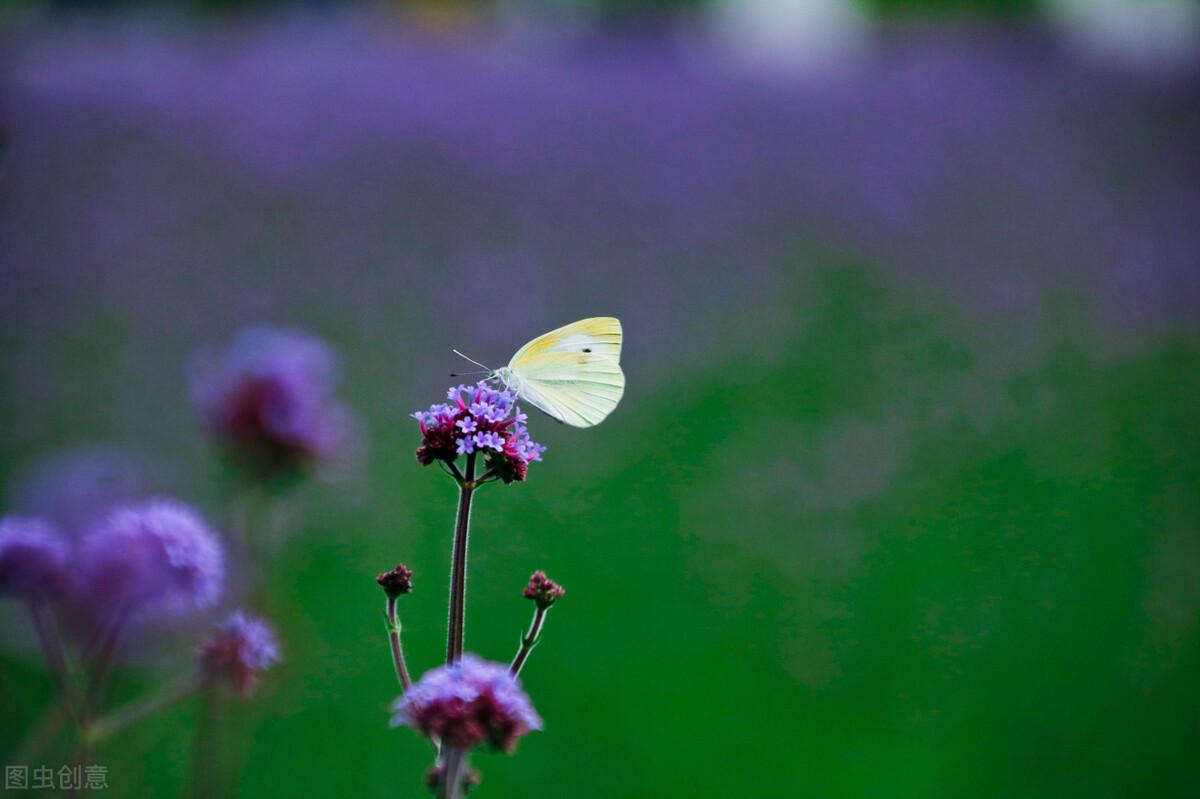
[0,0,1200,799]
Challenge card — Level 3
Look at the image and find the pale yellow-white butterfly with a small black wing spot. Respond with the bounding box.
[455,317,625,427]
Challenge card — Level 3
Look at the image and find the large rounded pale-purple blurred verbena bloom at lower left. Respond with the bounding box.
[78,499,224,613]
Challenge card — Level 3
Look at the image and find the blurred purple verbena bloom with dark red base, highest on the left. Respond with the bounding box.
[192,326,352,469]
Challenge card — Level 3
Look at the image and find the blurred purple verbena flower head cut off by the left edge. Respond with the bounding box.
[0,516,70,600]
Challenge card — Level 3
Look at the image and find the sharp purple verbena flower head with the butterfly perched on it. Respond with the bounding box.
[413,380,546,482]
